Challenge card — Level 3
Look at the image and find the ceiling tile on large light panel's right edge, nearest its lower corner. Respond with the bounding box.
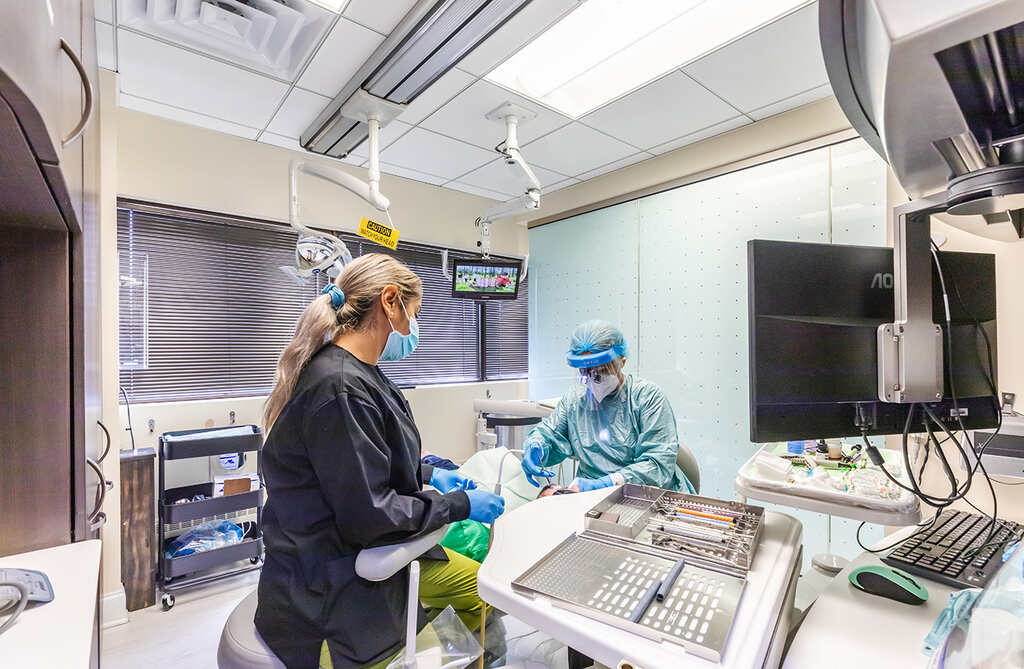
[580,70,737,149]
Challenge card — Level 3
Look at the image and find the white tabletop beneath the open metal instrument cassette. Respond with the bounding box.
[477,488,802,669]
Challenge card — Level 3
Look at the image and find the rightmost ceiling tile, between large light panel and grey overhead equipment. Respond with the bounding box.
[684,3,828,112]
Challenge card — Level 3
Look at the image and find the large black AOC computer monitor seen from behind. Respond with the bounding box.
[748,240,998,443]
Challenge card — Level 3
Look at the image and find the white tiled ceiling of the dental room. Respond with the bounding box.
[96,0,831,201]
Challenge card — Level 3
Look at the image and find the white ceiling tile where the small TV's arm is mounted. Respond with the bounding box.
[420,79,570,149]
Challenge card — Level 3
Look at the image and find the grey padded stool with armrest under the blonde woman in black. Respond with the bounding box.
[217,526,447,669]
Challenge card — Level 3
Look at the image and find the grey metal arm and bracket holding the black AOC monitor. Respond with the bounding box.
[878,193,946,404]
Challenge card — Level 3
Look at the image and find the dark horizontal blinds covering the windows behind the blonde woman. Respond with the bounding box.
[118,202,527,402]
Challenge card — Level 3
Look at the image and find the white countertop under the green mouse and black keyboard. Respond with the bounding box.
[783,528,953,669]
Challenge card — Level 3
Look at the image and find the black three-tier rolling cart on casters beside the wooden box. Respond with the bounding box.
[157,425,263,611]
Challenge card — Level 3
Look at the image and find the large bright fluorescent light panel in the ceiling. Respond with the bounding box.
[485,0,810,118]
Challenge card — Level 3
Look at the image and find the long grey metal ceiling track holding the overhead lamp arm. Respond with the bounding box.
[300,0,530,158]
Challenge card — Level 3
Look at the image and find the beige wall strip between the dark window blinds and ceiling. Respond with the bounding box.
[117,105,527,254]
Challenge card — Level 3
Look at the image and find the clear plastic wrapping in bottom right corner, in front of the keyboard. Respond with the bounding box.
[930,544,1024,669]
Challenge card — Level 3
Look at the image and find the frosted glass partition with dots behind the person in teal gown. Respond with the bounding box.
[529,139,886,556]
